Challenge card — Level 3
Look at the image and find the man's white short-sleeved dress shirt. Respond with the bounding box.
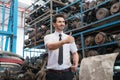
[44,32,77,70]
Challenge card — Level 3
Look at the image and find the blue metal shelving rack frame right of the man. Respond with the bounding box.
[57,0,120,57]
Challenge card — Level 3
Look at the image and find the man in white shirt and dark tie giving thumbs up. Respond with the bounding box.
[44,14,79,80]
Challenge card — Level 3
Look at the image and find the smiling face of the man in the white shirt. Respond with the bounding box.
[53,17,65,31]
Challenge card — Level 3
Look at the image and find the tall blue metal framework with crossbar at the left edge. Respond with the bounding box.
[0,0,18,53]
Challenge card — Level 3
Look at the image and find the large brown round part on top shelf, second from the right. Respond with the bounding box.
[96,8,109,20]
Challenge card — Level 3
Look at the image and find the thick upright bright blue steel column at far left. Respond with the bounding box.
[5,0,18,53]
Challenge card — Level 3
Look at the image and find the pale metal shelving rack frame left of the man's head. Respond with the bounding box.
[23,0,54,57]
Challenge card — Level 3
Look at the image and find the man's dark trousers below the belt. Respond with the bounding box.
[46,71,74,80]
